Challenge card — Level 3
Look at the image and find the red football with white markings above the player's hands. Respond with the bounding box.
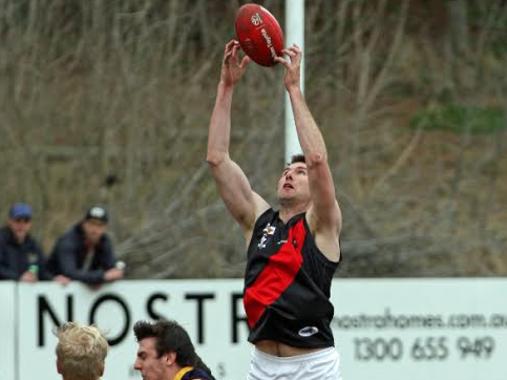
[235,4,283,66]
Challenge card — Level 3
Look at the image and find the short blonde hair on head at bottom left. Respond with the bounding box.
[56,322,109,380]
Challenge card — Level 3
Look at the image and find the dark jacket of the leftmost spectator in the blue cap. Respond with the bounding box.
[0,226,52,280]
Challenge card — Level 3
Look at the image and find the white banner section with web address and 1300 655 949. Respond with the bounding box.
[333,279,507,380]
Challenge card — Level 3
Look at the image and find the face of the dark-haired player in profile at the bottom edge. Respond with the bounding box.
[134,338,167,380]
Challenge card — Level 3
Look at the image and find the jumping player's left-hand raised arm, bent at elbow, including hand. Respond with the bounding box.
[206,40,269,241]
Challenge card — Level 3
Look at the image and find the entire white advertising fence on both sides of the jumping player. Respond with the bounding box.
[0,279,507,380]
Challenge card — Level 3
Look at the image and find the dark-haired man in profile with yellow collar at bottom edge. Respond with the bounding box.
[134,320,214,380]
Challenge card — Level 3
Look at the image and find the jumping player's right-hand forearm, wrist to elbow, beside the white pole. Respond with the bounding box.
[288,86,327,164]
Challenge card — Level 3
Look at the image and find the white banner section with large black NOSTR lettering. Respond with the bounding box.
[19,280,250,380]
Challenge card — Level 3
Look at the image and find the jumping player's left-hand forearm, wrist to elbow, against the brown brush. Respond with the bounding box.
[206,82,234,164]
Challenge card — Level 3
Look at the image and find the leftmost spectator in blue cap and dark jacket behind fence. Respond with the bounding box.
[0,203,65,283]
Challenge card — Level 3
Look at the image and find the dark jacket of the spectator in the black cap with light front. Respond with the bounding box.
[48,223,116,284]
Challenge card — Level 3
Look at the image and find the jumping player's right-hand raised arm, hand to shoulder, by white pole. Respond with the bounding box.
[276,45,341,261]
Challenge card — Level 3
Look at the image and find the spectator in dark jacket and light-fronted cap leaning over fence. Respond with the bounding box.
[48,206,123,285]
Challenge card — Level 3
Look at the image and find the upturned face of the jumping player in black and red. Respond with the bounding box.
[277,162,310,202]
